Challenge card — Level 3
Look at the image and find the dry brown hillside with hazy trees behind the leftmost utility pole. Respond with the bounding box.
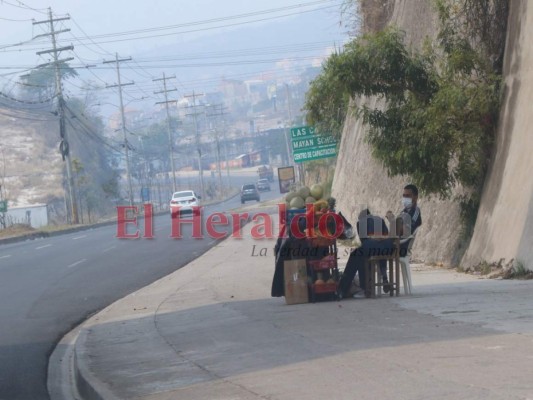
[0,99,118,223]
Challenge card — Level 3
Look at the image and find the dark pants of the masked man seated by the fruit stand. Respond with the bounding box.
[339,239,394,295]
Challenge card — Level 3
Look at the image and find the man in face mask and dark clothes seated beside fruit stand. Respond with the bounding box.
[339,185,422,297]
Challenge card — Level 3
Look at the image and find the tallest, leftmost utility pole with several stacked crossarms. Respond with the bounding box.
[33,8,79,224]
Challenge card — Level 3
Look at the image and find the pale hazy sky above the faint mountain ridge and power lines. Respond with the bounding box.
[0,0,341,65]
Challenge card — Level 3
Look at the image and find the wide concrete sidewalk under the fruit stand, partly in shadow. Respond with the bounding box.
[64,216,533,400]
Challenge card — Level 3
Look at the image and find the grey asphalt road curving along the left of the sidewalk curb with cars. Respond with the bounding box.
[0,177,279,400]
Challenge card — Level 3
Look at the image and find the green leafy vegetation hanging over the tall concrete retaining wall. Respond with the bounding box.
[305,0,508,237]
